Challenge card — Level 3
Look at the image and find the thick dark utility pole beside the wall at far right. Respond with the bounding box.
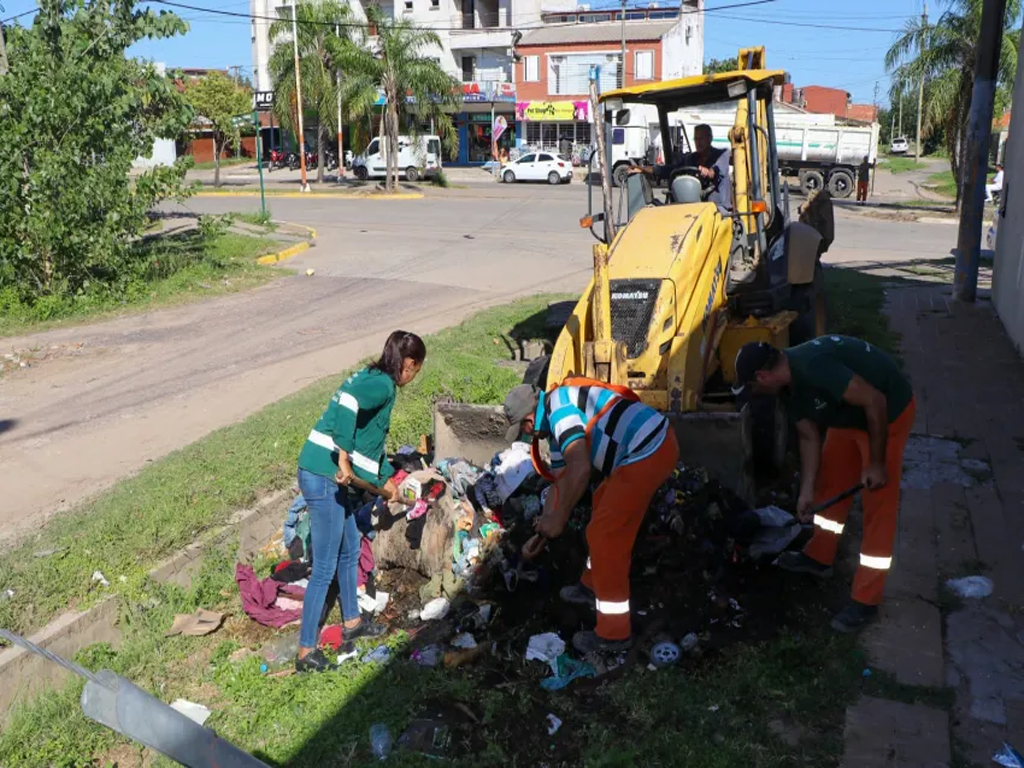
[953,0,1007,301]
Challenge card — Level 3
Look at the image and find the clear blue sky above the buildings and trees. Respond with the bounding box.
[0,0,929,104]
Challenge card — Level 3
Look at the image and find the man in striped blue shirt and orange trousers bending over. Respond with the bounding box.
[505,379,679,653]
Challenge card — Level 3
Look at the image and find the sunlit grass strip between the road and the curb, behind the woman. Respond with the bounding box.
[0,297,561,632]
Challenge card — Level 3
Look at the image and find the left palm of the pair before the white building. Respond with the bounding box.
[268,0,353,182]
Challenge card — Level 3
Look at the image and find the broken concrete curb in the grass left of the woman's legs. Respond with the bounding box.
[0,488,292,725]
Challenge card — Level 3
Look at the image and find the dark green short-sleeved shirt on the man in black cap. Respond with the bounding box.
[784,336,913,430]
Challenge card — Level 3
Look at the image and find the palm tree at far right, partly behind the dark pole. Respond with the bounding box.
[886,0,1021,208]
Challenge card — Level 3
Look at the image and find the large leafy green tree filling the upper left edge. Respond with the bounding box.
[0,0,191,303]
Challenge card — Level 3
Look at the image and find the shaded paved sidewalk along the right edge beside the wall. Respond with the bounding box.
[843,271,1024,768]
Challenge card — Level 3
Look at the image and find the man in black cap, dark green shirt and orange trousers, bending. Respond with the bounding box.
[736,336,915,632]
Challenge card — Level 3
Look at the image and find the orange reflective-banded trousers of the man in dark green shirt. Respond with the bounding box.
[804,399,918,605]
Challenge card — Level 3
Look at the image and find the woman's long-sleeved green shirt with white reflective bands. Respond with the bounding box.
[299,369,396,485]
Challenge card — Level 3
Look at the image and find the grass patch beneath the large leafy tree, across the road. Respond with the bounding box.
[0,229,281,337]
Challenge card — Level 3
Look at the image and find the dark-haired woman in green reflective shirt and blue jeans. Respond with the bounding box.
[295,331,427,672]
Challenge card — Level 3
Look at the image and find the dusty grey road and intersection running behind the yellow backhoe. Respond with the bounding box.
[0,184,955,542]
